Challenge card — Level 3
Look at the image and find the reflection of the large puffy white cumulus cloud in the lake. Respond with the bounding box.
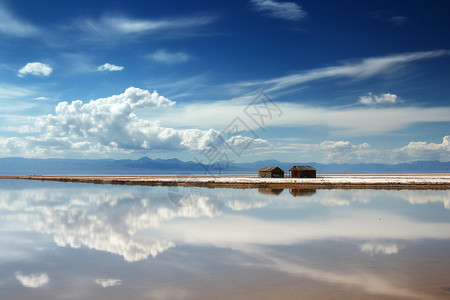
[0,188,267,261]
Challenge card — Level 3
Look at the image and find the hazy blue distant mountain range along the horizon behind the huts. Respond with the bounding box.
[0,157,450,175]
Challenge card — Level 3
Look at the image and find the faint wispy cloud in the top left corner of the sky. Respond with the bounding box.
[0,4,40,37]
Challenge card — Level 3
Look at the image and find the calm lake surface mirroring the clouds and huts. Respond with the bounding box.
[0,180,450,300]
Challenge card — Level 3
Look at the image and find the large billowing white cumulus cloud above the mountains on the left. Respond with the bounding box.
[0,87,268,156]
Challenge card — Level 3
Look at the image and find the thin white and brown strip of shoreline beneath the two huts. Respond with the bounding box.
[0,174,450,190]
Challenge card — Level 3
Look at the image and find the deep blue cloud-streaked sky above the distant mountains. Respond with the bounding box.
[0,0,450,164]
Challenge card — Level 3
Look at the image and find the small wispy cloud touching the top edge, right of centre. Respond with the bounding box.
[250,0,306,21]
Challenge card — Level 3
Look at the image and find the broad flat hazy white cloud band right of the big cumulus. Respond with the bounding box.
[152,97,450,136]
